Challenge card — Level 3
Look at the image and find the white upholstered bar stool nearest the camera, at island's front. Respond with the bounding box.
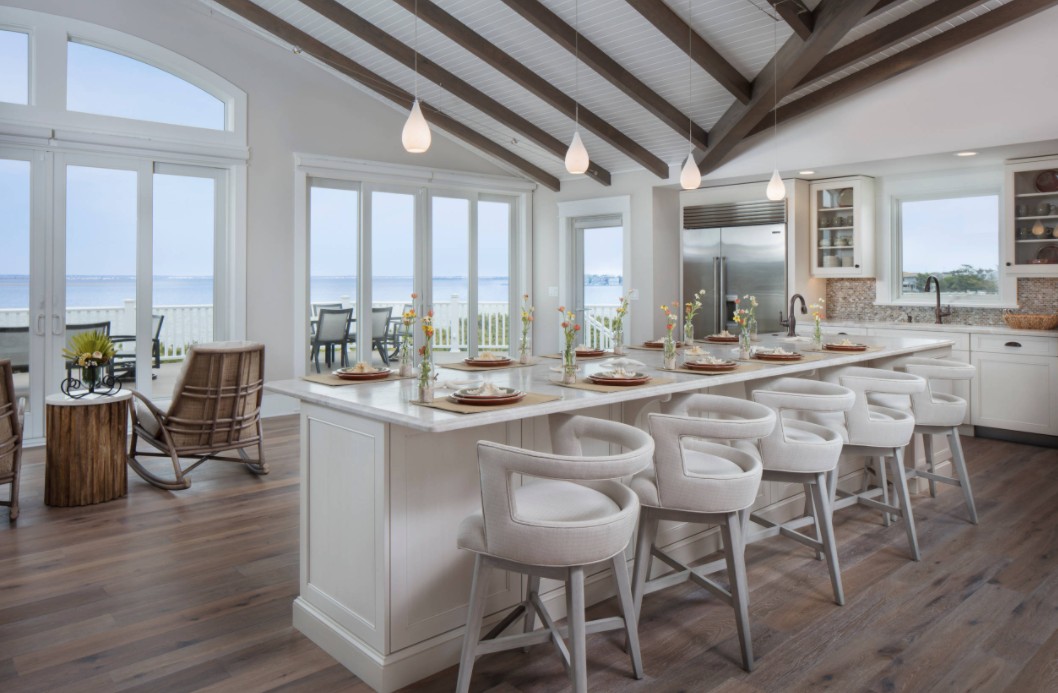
[456,415,654,693]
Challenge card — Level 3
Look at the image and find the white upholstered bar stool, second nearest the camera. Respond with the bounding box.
[631,395,776,671]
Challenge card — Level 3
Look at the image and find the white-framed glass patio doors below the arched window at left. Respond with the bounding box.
[0,149,229,438]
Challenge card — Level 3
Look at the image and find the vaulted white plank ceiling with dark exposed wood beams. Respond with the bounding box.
[203,0,1058,189]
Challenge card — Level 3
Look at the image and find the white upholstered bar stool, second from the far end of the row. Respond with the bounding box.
[806,366,926,561]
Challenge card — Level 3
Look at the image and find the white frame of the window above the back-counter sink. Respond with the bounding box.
[875,168,1018,308]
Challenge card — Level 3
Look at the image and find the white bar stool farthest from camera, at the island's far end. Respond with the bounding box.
[900,357,978,525]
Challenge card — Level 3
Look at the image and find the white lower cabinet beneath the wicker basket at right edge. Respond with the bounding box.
[971,334,1058,436]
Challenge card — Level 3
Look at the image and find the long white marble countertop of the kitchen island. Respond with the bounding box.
[265,336,952,433]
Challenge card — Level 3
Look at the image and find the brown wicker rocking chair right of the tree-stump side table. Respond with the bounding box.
[128,342,269,491]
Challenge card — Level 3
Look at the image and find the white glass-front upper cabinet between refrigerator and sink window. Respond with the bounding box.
[809,176,874,277]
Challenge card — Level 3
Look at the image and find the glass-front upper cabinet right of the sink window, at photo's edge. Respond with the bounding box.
[1004,158,1058,276]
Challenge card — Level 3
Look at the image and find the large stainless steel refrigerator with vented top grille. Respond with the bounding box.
[682,201,786,338]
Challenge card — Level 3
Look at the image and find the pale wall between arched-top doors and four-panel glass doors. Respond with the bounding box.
[0,0,508,380]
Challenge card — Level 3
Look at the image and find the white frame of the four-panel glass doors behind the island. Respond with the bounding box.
[292,153,536,377]
